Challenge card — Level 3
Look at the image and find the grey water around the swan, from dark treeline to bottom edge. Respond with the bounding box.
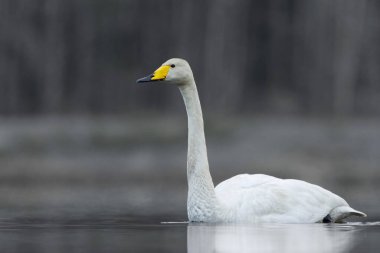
[0,118,380,253]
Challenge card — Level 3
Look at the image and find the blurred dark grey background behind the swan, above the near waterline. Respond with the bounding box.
[0,0,380,220]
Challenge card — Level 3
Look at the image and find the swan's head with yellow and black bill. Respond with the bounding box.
[137,58,193,85]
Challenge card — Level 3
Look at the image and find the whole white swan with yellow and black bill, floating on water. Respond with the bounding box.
[136,58,366,223]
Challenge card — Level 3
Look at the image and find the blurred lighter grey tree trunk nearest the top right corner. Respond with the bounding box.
[333,0,367,115]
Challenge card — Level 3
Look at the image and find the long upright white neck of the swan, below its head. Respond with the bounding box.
[179,80,217,221]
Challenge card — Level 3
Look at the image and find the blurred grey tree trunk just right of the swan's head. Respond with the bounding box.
[204,0,248,112]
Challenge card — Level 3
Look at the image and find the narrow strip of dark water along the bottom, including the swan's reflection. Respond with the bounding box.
[0,217,380,253]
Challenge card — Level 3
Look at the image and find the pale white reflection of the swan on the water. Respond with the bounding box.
[187,224,355,253]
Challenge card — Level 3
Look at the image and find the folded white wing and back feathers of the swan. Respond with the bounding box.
[215,174,355,223]
